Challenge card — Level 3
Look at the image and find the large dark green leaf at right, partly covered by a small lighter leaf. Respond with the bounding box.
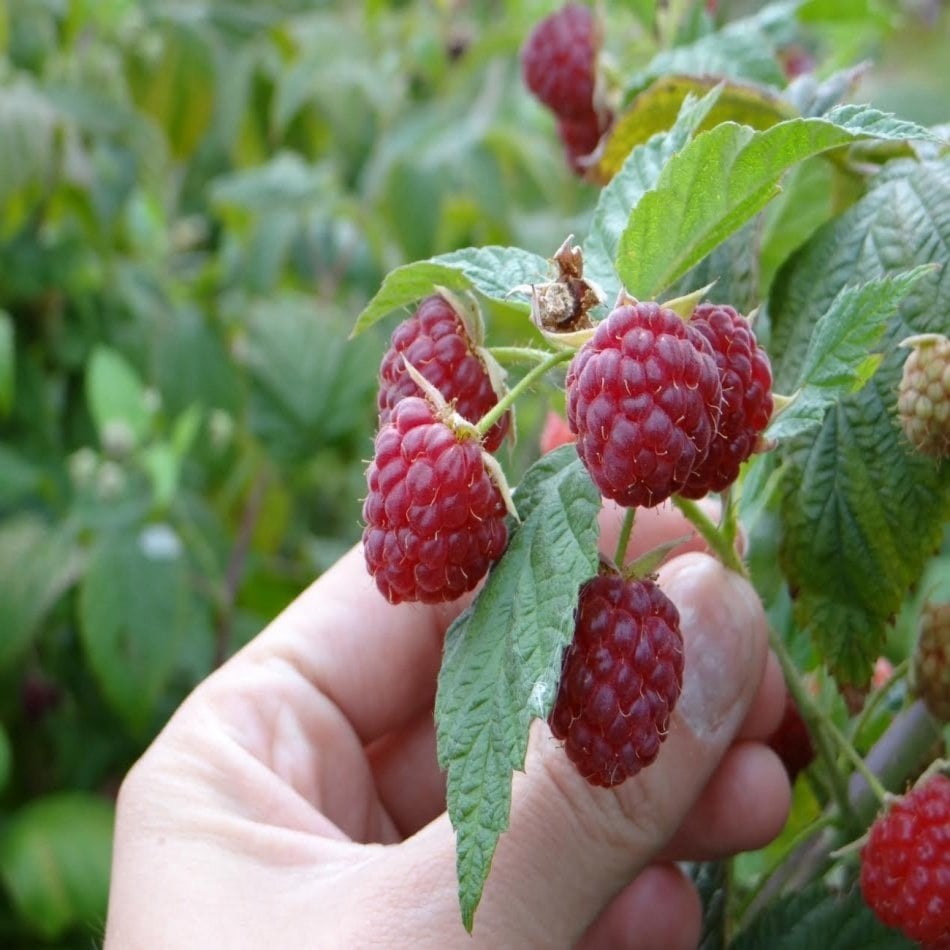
[769,161,950,683]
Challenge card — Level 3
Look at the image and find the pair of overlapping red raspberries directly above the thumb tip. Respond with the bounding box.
[567,301,772,508]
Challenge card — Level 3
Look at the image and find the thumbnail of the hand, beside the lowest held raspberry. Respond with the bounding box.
[660,554,765,739]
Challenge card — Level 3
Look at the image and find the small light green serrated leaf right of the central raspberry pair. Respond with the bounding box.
[765,264,936,441]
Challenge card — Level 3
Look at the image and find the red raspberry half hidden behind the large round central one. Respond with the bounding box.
[680,304,772,498]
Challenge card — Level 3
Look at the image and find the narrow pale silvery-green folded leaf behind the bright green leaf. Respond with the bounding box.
[584,86,723,302]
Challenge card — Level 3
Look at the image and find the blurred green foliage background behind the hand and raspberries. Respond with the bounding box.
[0,0,950,947]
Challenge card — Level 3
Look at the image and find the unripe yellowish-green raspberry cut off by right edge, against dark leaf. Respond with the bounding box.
[897,333,950,458]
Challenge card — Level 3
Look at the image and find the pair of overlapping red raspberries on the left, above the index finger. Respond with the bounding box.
[363,294,511,604]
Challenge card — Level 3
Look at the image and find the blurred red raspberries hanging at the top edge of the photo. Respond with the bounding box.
[521,3,610,174]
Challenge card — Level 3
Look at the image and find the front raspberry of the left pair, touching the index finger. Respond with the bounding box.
[363,396,508,604]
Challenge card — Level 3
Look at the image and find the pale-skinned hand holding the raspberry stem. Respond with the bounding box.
[106,509,789,950]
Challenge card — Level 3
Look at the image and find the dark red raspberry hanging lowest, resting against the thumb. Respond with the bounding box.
[550,574,683,788]
